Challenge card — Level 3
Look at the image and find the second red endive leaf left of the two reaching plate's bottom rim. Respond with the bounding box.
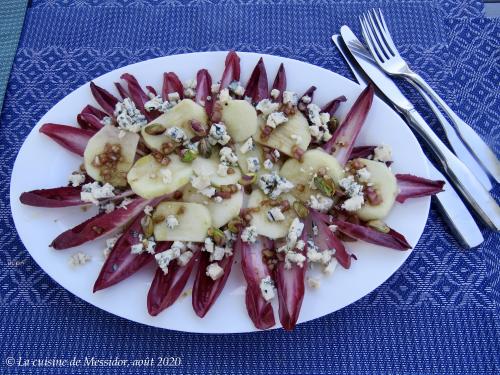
[147,246,201,316]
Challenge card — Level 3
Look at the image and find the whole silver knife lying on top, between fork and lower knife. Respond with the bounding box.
[340,26,500,231]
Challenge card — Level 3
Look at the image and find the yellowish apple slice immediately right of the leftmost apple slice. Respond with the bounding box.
[127,154,193,199]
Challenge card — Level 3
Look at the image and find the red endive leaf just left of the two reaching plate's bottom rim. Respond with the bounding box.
[192,251,234,318]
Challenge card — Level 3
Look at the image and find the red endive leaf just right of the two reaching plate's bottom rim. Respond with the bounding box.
[310,210,351,269]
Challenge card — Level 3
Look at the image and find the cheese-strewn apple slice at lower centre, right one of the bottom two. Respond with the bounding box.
[248,189,297,240]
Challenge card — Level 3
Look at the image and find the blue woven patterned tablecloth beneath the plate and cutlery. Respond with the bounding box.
[0,0,500,374]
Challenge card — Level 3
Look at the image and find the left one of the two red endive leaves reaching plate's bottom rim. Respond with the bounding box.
[239,236,276,329]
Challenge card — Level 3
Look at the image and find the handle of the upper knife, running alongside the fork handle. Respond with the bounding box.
[403,109,500,231]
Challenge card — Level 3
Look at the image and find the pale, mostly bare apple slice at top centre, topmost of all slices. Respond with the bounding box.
[222,100,259,142]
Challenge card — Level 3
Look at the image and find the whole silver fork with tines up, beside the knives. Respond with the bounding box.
[360,9,500,182]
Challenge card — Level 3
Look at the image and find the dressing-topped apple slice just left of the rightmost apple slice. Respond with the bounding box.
[280,148,344,202]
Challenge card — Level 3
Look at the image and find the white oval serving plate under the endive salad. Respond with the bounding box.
[10,52,430,333]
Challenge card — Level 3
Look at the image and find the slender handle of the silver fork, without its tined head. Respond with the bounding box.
[405,72,500,182]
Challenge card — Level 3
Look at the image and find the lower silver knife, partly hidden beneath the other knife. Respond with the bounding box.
[332,35,484,249]
